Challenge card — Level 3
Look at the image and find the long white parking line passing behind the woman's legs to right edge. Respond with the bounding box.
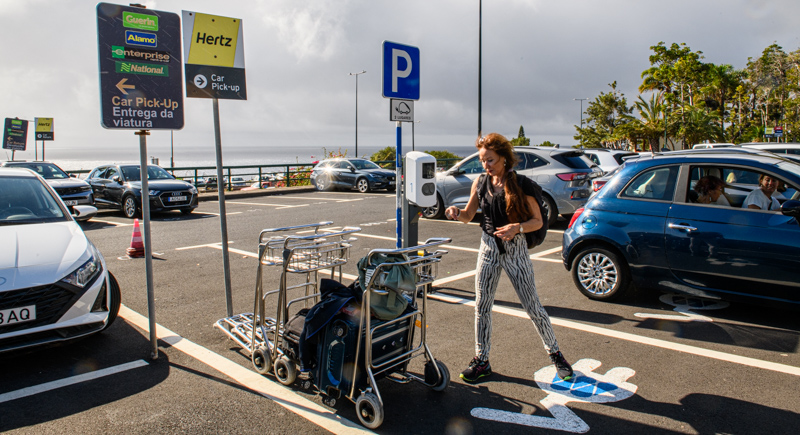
[428,292,800,376]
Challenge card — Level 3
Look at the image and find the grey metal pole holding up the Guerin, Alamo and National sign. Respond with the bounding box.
[135,130,158,359]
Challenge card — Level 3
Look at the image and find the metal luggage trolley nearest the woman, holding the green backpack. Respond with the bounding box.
[334,238,451,429]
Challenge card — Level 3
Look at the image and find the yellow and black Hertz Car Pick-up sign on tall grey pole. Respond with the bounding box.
[182,11,247,317]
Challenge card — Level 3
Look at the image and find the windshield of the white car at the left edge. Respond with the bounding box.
[0,177,69,225]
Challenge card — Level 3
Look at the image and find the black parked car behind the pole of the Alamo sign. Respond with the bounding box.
[86,165,197,219]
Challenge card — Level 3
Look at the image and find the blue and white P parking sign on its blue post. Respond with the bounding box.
[382,41,420,248]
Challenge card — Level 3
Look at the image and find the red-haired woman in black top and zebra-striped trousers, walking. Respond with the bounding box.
[445,133,572,382]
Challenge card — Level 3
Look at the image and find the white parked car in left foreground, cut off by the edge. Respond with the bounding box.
[0,167,120,352]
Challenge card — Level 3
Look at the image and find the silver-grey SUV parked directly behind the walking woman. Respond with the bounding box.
[422,147,603,224]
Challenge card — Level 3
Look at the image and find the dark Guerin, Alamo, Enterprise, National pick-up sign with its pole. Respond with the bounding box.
[97,3,183,359]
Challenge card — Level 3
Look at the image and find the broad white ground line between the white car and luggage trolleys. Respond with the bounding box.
[119,305,372,434]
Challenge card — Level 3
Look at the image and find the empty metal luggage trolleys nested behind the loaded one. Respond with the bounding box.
[215,222,361,385]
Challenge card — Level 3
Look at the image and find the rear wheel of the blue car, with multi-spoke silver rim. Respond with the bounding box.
[572,246,631,301]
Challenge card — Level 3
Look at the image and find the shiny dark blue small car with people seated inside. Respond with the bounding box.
[561,150,800,307]
